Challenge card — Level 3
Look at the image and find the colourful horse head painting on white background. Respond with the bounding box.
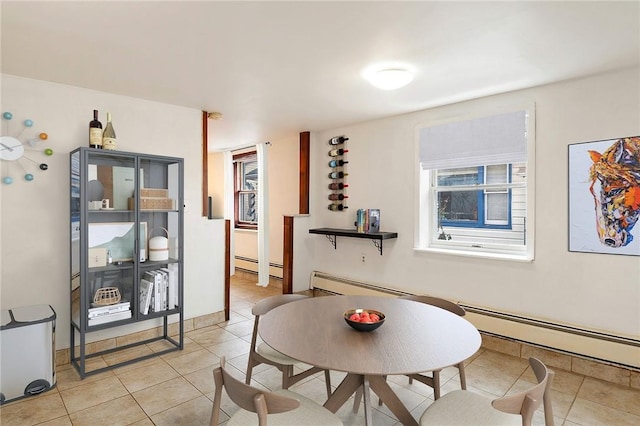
[569,136,640,256]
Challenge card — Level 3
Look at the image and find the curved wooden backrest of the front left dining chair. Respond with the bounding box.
[211,357,300,426]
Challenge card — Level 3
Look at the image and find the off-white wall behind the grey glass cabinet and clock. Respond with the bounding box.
[0,74,224,348]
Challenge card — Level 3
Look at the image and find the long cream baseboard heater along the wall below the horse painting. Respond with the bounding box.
[310,271,640,370]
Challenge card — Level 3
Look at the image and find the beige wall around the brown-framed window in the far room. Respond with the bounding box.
[209,134,300,265]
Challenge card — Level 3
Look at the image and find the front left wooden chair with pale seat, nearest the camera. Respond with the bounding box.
[211,357,342,426]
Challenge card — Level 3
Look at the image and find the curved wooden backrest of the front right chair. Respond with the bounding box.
[491,358,549,426]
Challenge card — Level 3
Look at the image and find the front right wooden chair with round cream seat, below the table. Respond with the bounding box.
[420,358,553,426]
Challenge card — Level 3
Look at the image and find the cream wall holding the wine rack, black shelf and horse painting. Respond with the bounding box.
[307,68,640,339]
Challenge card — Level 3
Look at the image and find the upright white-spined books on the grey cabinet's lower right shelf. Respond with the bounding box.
[139,265,178,315]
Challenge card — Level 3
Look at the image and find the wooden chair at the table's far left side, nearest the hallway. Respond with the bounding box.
[245,294,331,398]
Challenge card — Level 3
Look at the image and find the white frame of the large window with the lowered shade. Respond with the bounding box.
[414,103,535,262]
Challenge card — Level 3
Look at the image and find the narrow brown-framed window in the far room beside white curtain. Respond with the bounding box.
[233,151,259,229]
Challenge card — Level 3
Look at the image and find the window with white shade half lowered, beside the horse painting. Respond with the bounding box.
[416,107,533,260]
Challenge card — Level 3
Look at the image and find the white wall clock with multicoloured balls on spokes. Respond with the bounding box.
[0,112,53,185]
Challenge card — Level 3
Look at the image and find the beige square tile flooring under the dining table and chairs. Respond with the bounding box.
[0,278,640,426]
